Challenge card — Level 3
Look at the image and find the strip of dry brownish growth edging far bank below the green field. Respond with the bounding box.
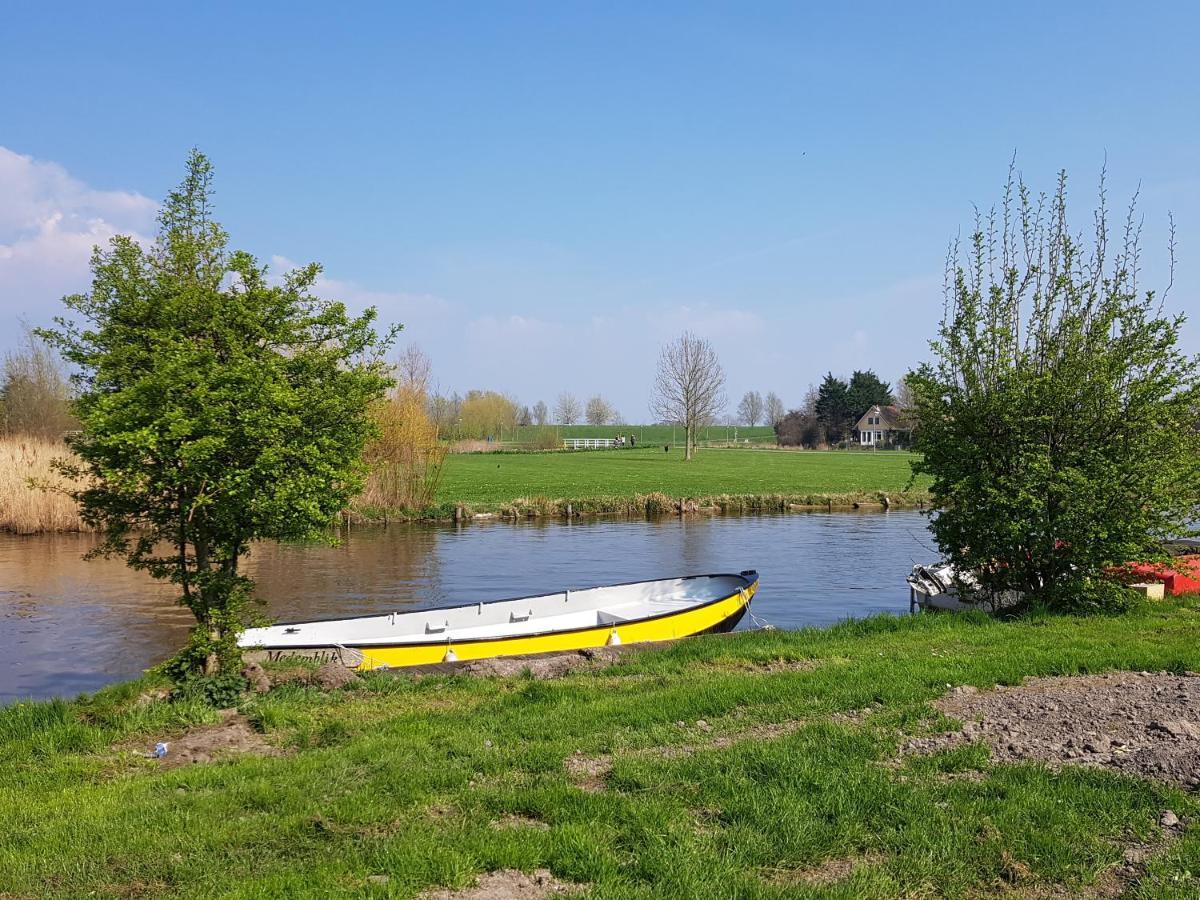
[343,491,932,526]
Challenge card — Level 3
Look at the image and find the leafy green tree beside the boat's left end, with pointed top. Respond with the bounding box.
[43,151,394,672]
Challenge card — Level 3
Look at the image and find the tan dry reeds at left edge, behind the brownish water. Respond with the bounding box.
[0,436,91,534]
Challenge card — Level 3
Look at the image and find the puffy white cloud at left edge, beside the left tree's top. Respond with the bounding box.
[0,146,157,333]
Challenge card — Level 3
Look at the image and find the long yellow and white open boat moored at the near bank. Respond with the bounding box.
[239,571,758,668]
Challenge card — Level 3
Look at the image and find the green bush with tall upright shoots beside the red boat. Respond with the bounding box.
[907,165,1200,608]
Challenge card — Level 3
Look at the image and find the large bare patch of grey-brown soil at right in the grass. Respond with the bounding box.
[904,672,1200,790]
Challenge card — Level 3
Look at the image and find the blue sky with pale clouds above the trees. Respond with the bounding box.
[0,2,1200,420]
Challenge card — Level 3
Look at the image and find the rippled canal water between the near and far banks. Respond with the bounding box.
[0,511,934,703]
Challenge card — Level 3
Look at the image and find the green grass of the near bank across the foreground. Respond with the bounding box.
[0,604,1200,898]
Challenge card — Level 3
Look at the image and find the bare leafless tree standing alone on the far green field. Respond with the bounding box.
[650,331,725,460]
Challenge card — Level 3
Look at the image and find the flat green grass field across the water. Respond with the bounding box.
[438,446,924,505]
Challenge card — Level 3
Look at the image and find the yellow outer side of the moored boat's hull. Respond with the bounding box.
[244,576,758,670]
